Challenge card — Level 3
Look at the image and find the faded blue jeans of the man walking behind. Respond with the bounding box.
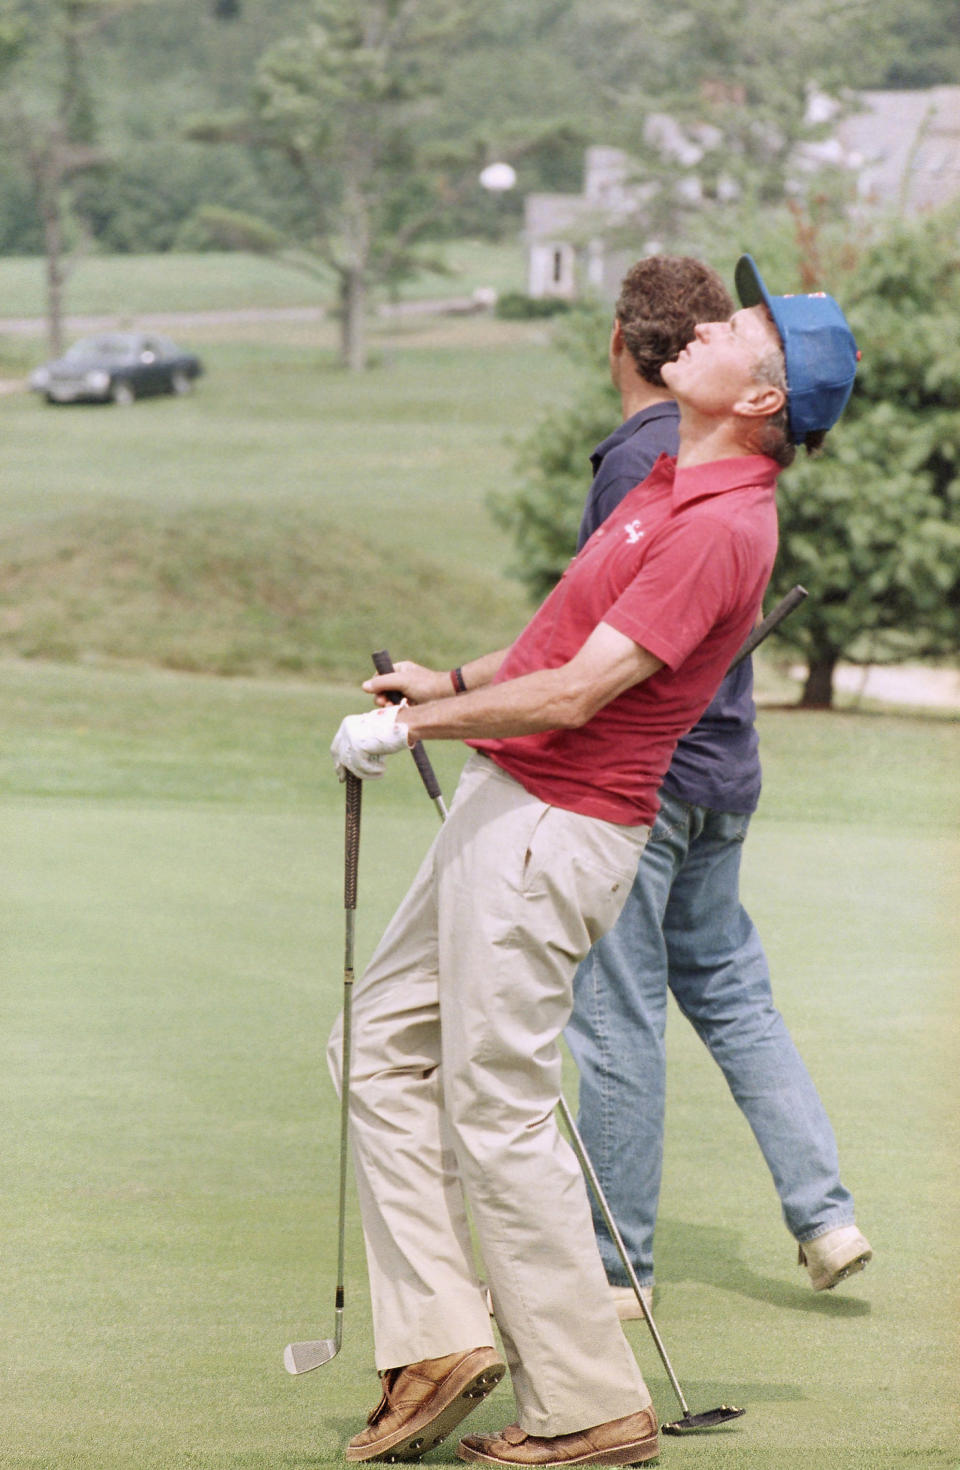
[566,791,854,1286]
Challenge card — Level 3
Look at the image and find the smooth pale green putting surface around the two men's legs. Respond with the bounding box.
[0,662,960,1470]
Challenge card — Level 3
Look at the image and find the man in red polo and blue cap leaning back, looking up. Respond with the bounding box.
[329,257,856,1466]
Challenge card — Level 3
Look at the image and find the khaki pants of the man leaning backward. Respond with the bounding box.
[329,754,650,1435]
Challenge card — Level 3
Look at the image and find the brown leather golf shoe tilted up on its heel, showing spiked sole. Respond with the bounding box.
[347,1348,506,1460]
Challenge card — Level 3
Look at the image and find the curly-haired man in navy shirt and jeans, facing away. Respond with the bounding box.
[566,256,870,1317]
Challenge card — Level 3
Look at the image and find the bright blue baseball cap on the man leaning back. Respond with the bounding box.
[734,256,860,444]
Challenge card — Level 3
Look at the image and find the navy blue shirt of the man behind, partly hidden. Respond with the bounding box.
[576,400,760,813]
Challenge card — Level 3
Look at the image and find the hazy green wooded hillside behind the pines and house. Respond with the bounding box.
[0,0,960,254]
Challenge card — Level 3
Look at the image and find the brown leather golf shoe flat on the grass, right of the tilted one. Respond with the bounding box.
[457,1408,660,1466]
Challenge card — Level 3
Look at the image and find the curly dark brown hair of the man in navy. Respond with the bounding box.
[616,256,734,388]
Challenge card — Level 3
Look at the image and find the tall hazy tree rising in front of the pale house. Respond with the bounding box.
[546,0,856,251]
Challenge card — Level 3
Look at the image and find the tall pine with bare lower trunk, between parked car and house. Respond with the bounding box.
[191,0,482,369]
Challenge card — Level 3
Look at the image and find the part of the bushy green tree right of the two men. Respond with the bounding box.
[772,210,960,707]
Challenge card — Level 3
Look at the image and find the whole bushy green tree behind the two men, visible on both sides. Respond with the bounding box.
[492,210,960,707]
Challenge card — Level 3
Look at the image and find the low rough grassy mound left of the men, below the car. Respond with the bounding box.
[0,506,526,681]
